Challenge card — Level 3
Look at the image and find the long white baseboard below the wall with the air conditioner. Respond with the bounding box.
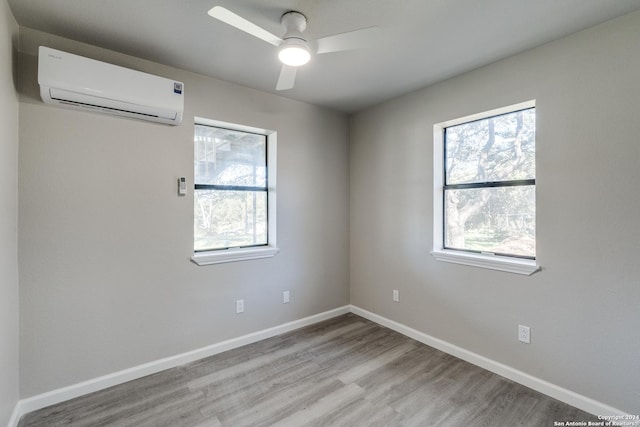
[7,305,350,427]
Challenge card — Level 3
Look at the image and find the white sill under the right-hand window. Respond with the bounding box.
[431,250,540,276]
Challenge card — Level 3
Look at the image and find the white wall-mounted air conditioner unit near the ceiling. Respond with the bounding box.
[38,46,184,125]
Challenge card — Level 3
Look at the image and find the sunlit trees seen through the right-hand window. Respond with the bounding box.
[445,108,535,256]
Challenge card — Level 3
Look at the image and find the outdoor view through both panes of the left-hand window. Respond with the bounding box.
[194,125,267,250]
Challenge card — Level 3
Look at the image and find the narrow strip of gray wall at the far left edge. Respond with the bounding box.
[0,1,18,425]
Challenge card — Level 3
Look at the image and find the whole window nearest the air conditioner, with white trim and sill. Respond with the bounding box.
[192,119,277,264]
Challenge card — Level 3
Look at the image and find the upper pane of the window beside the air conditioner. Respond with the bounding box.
[194,125,267,187]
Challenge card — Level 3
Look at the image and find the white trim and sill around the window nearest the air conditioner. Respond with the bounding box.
[191,117,280,266]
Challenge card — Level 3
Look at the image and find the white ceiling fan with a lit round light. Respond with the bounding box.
[208,6,379,90]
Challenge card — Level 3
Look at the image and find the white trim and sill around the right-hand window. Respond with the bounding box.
[431,100,540,276]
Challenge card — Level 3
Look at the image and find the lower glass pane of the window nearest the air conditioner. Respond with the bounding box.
[194,190,267,251]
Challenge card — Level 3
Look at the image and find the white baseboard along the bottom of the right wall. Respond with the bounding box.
[351,305,628,416]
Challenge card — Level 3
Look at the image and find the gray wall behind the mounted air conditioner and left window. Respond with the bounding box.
[19,28,349,397]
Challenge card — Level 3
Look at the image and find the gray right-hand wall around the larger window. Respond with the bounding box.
[350,13,640,414]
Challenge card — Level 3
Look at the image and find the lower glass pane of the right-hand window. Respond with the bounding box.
[445,185,536,257]
